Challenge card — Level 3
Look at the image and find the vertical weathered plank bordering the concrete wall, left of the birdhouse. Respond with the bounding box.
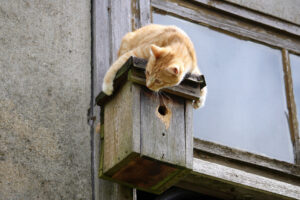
[90,0,113,200]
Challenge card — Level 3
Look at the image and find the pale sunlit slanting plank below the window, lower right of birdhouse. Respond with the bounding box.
[192,158,300,199]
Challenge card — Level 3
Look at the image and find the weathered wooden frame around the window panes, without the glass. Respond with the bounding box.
[150,0,300,199]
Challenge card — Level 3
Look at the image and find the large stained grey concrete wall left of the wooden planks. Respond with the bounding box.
[0,0,91,200]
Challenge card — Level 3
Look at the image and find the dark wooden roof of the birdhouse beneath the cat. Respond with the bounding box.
[96,57,206,106]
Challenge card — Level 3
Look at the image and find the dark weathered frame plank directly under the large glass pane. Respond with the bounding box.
[194,138,300,178]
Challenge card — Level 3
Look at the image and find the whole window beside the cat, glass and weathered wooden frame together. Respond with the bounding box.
[151,0,300,199]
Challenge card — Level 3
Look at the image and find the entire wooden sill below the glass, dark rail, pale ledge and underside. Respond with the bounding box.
[176,139,300,200]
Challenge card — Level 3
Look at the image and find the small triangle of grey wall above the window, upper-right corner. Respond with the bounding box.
[226,0,300,25]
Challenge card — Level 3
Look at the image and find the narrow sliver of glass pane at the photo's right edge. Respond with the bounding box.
[290,54,300,136]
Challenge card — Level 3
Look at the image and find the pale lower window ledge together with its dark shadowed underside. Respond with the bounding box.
[176,158,300,200]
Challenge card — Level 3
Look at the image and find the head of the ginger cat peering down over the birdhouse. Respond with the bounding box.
[146,45,184,91]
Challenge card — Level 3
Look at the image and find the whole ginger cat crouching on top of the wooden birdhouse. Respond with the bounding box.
[102,24,207,108]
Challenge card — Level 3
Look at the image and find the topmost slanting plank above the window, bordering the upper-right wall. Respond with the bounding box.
[194,0,300,36]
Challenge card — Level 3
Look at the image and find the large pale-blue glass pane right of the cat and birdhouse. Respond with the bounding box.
[153,14,294,162]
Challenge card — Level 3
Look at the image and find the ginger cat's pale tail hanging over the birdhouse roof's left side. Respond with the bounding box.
[102,51,134,95]
